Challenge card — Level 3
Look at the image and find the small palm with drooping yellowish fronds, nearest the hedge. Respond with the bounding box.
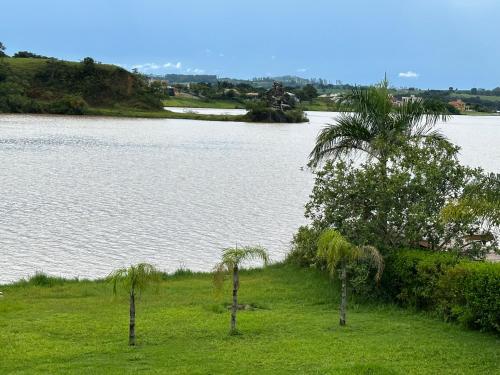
[318,229,384,326]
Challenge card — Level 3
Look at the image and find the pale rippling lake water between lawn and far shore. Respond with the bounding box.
[0,110,500,283]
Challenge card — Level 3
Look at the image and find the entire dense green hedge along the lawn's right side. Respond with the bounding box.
[382,250,500,332]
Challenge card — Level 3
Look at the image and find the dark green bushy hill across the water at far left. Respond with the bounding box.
[0,57,161,114]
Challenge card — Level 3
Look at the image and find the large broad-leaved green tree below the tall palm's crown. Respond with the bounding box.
[302,139,495,262]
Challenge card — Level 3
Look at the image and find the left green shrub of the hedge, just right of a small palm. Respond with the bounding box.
[382,250,460,309]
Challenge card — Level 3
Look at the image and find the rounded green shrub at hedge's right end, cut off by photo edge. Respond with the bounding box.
[436,261,500,332]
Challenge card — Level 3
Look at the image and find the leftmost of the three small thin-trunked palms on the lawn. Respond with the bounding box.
[108,263,161,346]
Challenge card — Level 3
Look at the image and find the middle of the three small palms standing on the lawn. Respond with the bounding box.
[214,246,269,334]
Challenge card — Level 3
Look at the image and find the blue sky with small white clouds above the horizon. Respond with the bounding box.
[0,0,500,89]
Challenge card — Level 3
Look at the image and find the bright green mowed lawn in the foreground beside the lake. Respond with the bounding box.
[0,265,500,374]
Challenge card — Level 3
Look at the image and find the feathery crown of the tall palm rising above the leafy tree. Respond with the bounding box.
[309,79,448,167]
